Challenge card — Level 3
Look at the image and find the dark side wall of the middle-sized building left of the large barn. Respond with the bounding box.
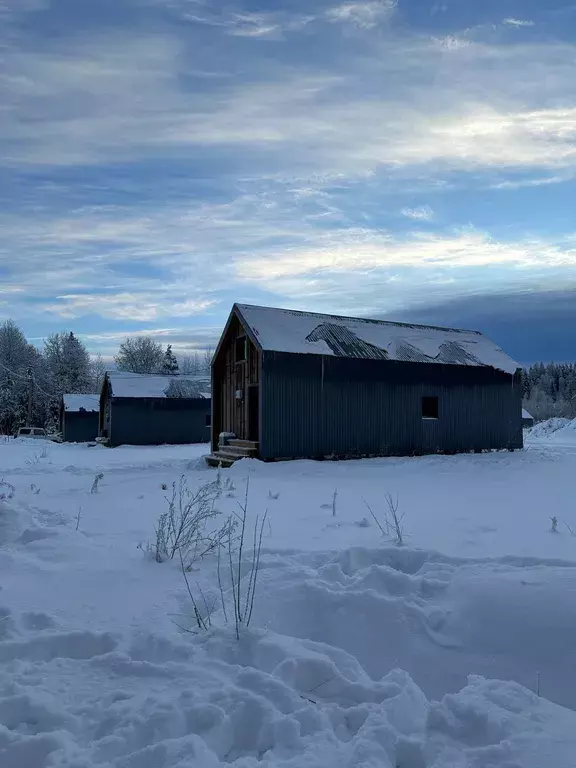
[110,397,210,445]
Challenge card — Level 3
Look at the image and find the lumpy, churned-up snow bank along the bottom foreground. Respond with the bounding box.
[0,630,576,768]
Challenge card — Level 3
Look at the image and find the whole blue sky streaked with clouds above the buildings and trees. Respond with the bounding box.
[0,0,576,362]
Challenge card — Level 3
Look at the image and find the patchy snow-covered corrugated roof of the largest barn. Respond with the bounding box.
[236,304,520,374]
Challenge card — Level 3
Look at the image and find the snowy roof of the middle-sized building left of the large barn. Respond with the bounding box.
[106,371,210,399]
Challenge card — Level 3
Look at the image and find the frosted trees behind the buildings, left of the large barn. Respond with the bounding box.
[0,320,212,435]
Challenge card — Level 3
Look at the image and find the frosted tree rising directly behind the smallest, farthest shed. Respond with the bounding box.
[44,331,92,397]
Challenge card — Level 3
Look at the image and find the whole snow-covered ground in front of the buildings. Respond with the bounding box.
[0,420,576,768]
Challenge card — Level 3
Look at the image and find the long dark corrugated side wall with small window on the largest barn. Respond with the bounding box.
[260,352,522,459]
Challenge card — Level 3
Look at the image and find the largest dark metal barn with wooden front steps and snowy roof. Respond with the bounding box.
[209,304,522,463]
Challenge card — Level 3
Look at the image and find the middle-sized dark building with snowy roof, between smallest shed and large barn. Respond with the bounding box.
[99,371,211,446]
